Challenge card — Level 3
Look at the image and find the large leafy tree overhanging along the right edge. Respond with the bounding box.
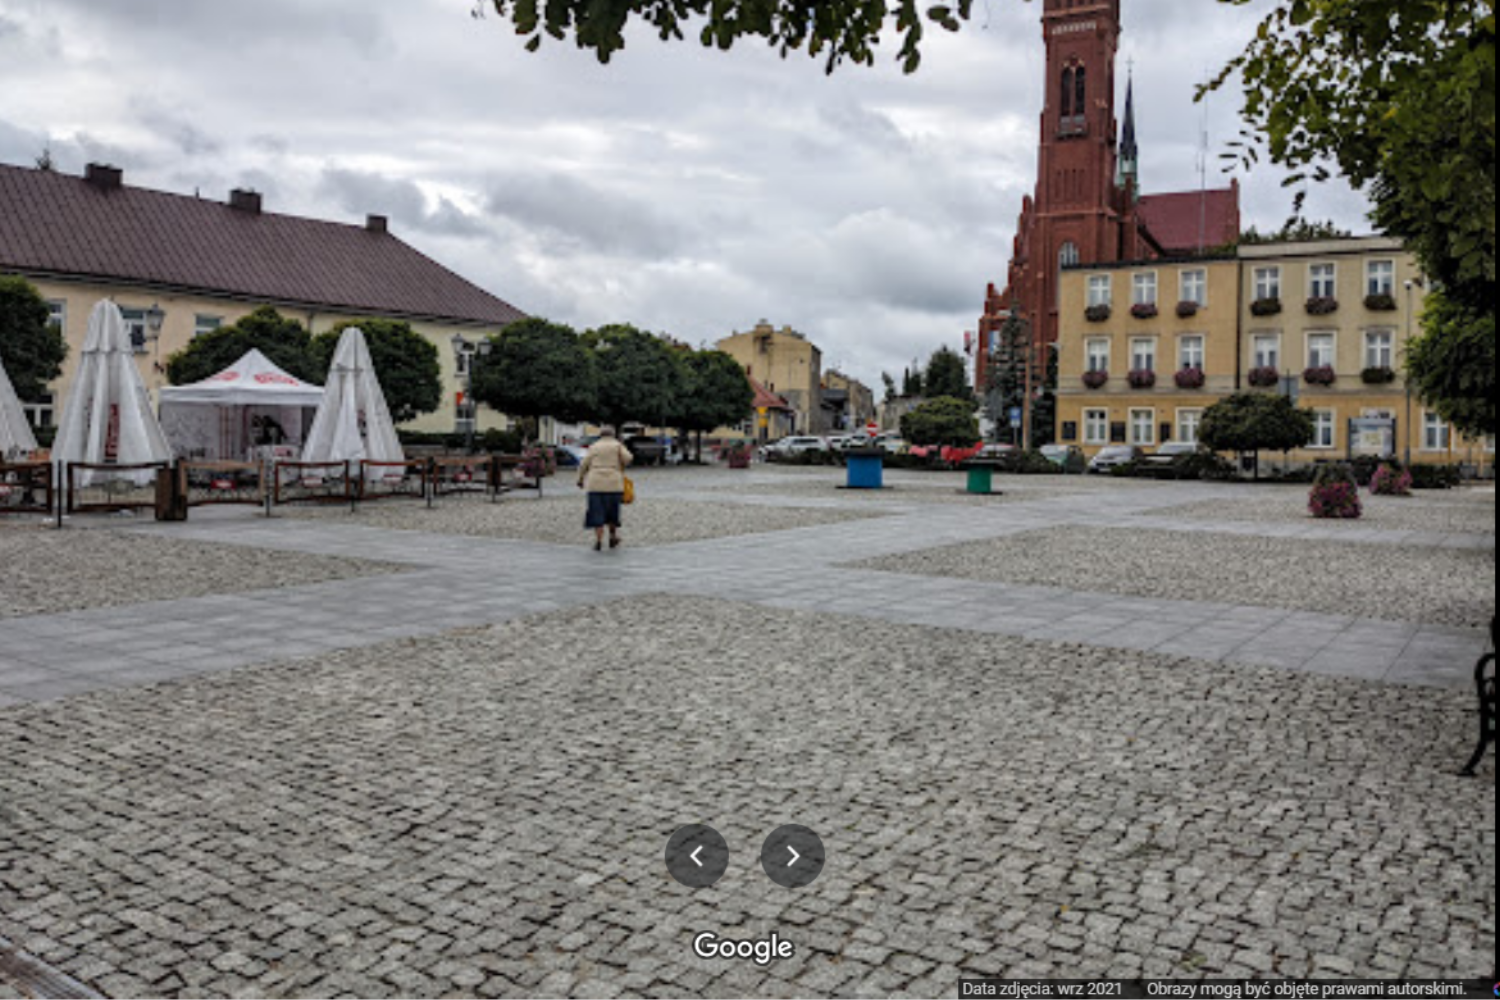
[1200,0,1496,433]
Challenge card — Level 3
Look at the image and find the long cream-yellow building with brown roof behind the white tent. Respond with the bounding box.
[0,163,525,432]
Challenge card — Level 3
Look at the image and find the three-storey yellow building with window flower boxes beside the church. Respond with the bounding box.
[1058,237,1494,468]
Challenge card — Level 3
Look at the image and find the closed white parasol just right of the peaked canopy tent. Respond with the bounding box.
[302,327,405,473]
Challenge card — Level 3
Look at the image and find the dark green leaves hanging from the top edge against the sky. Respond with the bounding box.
[473,0,974,73]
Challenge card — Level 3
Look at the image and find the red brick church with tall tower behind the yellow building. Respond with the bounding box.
[975,0,1239,394]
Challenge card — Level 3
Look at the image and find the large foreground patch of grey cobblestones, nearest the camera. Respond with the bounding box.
[0,597,1496,996]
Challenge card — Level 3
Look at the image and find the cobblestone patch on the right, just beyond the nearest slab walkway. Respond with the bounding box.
[854,525,1496,628]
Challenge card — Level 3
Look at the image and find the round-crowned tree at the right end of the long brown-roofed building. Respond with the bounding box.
[473,316,599,436]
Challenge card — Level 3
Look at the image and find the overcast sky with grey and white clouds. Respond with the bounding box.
[0,0,1370,387]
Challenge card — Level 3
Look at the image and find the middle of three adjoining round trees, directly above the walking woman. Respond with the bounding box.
[584,324,684,426]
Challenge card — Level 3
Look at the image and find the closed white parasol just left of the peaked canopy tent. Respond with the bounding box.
[53,298,173,486]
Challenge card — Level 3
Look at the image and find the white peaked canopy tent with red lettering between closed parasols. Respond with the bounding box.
[162,349,323,462]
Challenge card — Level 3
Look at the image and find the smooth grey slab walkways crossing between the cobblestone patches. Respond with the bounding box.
[0,471,1494,706]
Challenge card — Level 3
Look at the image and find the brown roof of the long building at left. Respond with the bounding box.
[0,163,525,325]
